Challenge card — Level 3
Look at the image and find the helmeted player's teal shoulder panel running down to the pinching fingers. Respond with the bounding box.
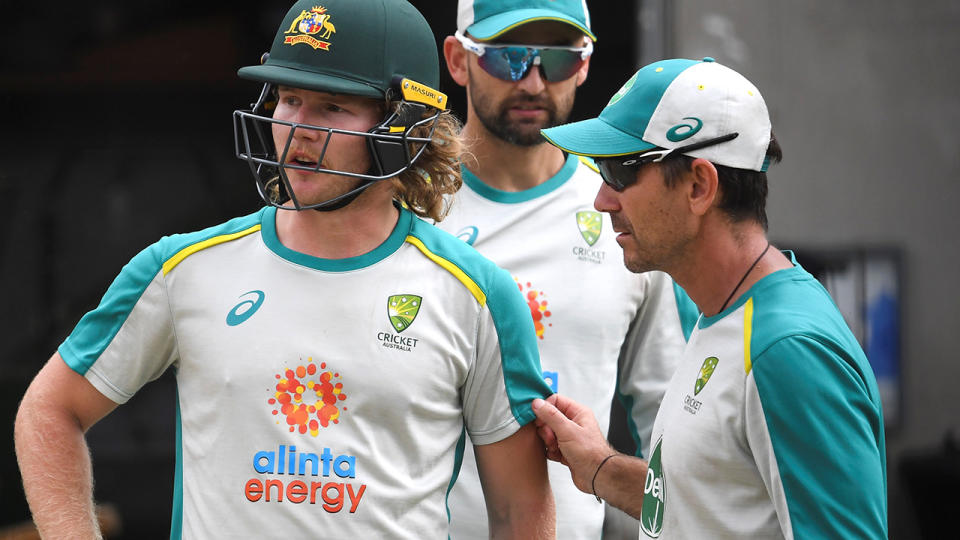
[410,218,553,425]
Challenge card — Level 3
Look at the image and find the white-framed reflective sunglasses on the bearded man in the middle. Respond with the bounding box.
[454,30,593,82]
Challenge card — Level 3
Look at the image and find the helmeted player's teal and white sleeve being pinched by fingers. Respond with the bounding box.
[463,269,551,444]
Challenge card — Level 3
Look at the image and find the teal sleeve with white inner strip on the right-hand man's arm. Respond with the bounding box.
[744,336,887,538]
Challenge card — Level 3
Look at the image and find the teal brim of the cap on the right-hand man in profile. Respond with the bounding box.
[540,118,656,157]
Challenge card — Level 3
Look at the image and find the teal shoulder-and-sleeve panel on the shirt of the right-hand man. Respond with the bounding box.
[749,266,887,538]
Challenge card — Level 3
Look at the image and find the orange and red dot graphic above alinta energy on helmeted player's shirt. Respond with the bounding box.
[267,358,347,437]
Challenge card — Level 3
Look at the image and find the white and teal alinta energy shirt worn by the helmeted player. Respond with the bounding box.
[59,208,550,539]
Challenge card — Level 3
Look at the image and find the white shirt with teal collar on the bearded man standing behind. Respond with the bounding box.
[438,156,696,539]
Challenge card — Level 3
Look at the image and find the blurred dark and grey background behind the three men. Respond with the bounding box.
[0,0,960,539]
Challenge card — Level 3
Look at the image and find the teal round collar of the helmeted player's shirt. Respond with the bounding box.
[260,207,414,272]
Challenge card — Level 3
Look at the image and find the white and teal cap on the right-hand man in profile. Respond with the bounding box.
[541,58,770,171]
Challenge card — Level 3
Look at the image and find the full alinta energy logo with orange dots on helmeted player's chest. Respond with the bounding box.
[243,358,367,514]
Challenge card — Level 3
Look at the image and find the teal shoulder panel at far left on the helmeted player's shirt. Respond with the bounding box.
[58,210,263,375]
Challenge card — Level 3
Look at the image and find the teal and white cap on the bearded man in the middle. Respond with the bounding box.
[457,0,597,41]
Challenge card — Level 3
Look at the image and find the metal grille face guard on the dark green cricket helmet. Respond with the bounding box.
[233,77,447,211]
